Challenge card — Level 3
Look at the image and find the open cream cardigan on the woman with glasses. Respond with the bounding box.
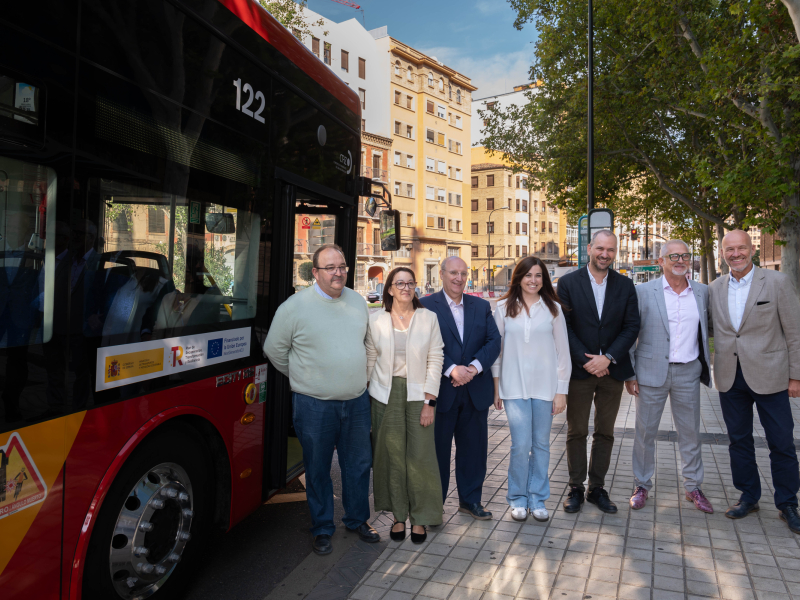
[365,308,444,404]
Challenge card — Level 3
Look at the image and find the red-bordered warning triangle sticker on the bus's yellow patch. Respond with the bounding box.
[0,431,47,519]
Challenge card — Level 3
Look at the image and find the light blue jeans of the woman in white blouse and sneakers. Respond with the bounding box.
[504,398,553,510]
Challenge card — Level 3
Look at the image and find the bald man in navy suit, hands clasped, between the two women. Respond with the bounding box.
[422,256,500,520]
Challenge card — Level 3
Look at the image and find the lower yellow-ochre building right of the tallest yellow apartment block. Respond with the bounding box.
[469,146,567,291]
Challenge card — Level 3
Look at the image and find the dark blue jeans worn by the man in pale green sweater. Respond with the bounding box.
[292,391,372,536]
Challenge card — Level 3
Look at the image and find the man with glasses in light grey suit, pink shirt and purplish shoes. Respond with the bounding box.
[625,240,714,513]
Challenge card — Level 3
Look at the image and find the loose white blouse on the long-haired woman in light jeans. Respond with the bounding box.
[492,299,572,402]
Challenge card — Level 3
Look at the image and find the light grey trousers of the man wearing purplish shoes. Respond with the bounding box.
[633,360,703,492]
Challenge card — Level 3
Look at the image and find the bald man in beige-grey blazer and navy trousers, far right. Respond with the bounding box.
[709,230,800,533]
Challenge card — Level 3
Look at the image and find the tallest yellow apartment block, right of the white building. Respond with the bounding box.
[389,37,477,289]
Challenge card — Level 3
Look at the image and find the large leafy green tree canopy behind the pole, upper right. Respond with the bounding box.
[480,0,800,293]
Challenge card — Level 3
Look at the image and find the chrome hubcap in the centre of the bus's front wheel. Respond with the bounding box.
[109,463,194,600]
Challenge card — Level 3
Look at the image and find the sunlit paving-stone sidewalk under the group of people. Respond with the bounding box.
[336,388,800,600]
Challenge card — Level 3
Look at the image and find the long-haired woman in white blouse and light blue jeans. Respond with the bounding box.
[492,256,572,521]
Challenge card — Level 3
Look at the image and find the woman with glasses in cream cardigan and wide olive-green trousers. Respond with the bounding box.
[366,267,444,544]
